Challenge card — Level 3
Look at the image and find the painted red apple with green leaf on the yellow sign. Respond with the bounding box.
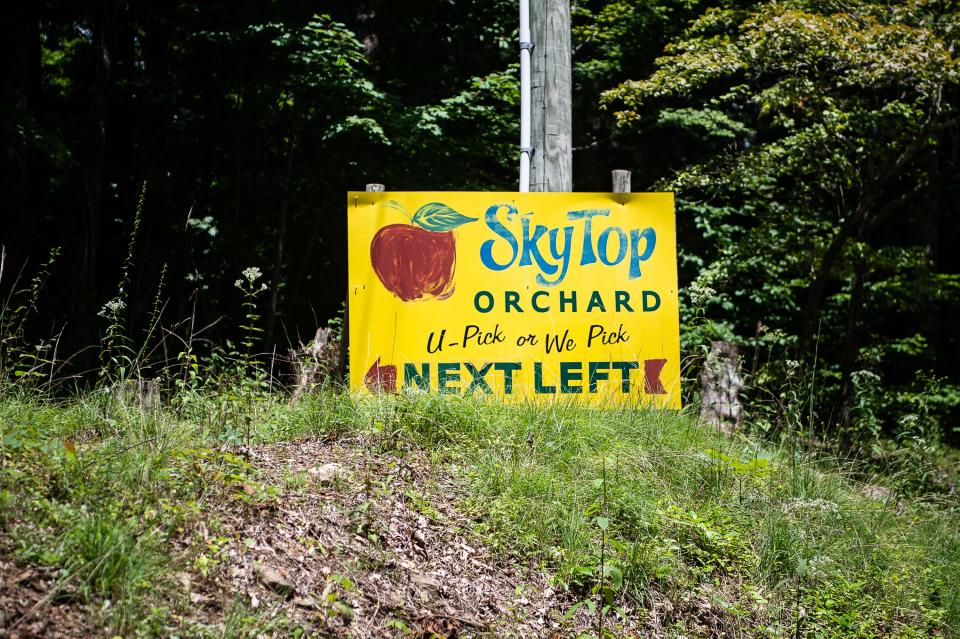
[370,201,477,302]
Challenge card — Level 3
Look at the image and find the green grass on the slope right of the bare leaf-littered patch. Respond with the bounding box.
[368,398,960,636]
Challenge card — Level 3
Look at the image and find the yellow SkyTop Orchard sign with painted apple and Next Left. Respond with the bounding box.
[347,192,680,408]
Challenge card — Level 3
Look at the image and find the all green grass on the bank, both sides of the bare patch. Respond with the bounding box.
[0,384,960,637]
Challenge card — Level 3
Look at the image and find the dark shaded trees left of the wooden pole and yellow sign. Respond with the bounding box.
[0,0,532,381]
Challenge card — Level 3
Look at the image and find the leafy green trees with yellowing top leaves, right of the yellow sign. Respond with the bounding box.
[602,0,960,444]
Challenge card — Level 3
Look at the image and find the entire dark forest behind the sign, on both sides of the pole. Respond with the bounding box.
[0,0,960,478]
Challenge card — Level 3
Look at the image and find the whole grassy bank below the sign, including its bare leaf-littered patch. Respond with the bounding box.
[0,392,960,637]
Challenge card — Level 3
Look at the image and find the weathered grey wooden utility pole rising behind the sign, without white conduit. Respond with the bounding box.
[529,0,573,191]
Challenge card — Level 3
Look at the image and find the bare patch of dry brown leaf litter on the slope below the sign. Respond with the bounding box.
[171,440,569,638]
